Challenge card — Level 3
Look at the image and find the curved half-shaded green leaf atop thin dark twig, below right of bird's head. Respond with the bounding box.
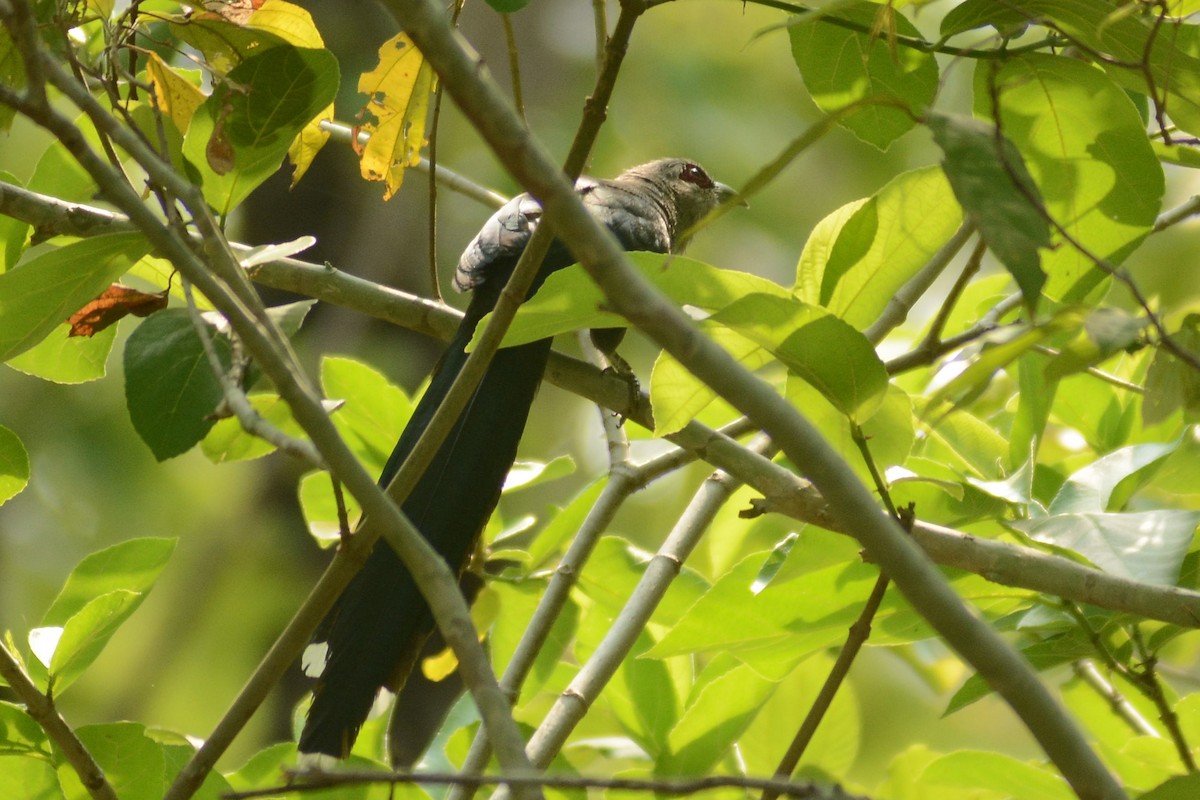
[709,294,888,421]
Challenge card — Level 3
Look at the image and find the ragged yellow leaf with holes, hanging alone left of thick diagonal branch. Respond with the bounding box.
[355,34,434,200]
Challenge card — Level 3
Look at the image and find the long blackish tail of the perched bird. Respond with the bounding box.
[300,296,551,758]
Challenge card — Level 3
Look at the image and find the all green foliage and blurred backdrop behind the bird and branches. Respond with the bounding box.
[0,0,1200,799]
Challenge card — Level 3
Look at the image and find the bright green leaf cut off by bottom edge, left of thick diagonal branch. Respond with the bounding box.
[920,750,1075,800]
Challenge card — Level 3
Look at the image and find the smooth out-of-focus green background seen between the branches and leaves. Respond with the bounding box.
[0,0,1198,783]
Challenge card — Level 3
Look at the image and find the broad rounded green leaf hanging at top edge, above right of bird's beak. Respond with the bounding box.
[787,2,937,150]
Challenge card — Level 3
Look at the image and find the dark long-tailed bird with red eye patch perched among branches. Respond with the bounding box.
[298,158,737,759]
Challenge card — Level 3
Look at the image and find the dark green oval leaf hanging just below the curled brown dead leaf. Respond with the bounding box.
[125,308,230,461]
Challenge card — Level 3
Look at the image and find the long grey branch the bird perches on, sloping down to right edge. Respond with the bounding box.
[0,182,1200,627]
